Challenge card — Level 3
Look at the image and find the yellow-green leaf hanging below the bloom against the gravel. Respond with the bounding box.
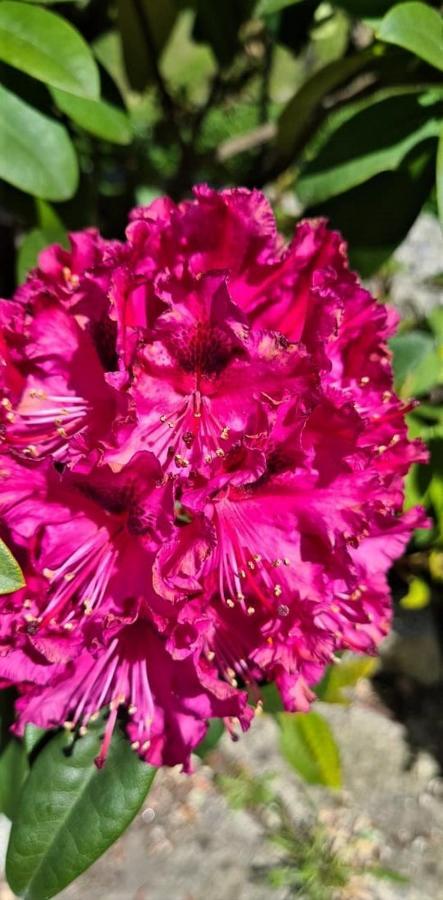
[277,712,341,788]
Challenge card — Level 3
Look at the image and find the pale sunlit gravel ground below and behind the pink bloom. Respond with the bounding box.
[0,215,443,900]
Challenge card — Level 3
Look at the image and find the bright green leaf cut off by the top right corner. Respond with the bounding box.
[377,3,443,70]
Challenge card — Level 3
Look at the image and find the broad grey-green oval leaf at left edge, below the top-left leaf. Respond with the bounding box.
[0,84,78,200]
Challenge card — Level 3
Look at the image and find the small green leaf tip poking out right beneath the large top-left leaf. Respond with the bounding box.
[51,88,132,144]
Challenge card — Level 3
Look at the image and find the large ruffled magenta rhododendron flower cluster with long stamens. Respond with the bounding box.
[0,186,423,768]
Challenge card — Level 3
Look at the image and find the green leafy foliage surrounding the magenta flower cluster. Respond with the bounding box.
[0,0,443,900]
